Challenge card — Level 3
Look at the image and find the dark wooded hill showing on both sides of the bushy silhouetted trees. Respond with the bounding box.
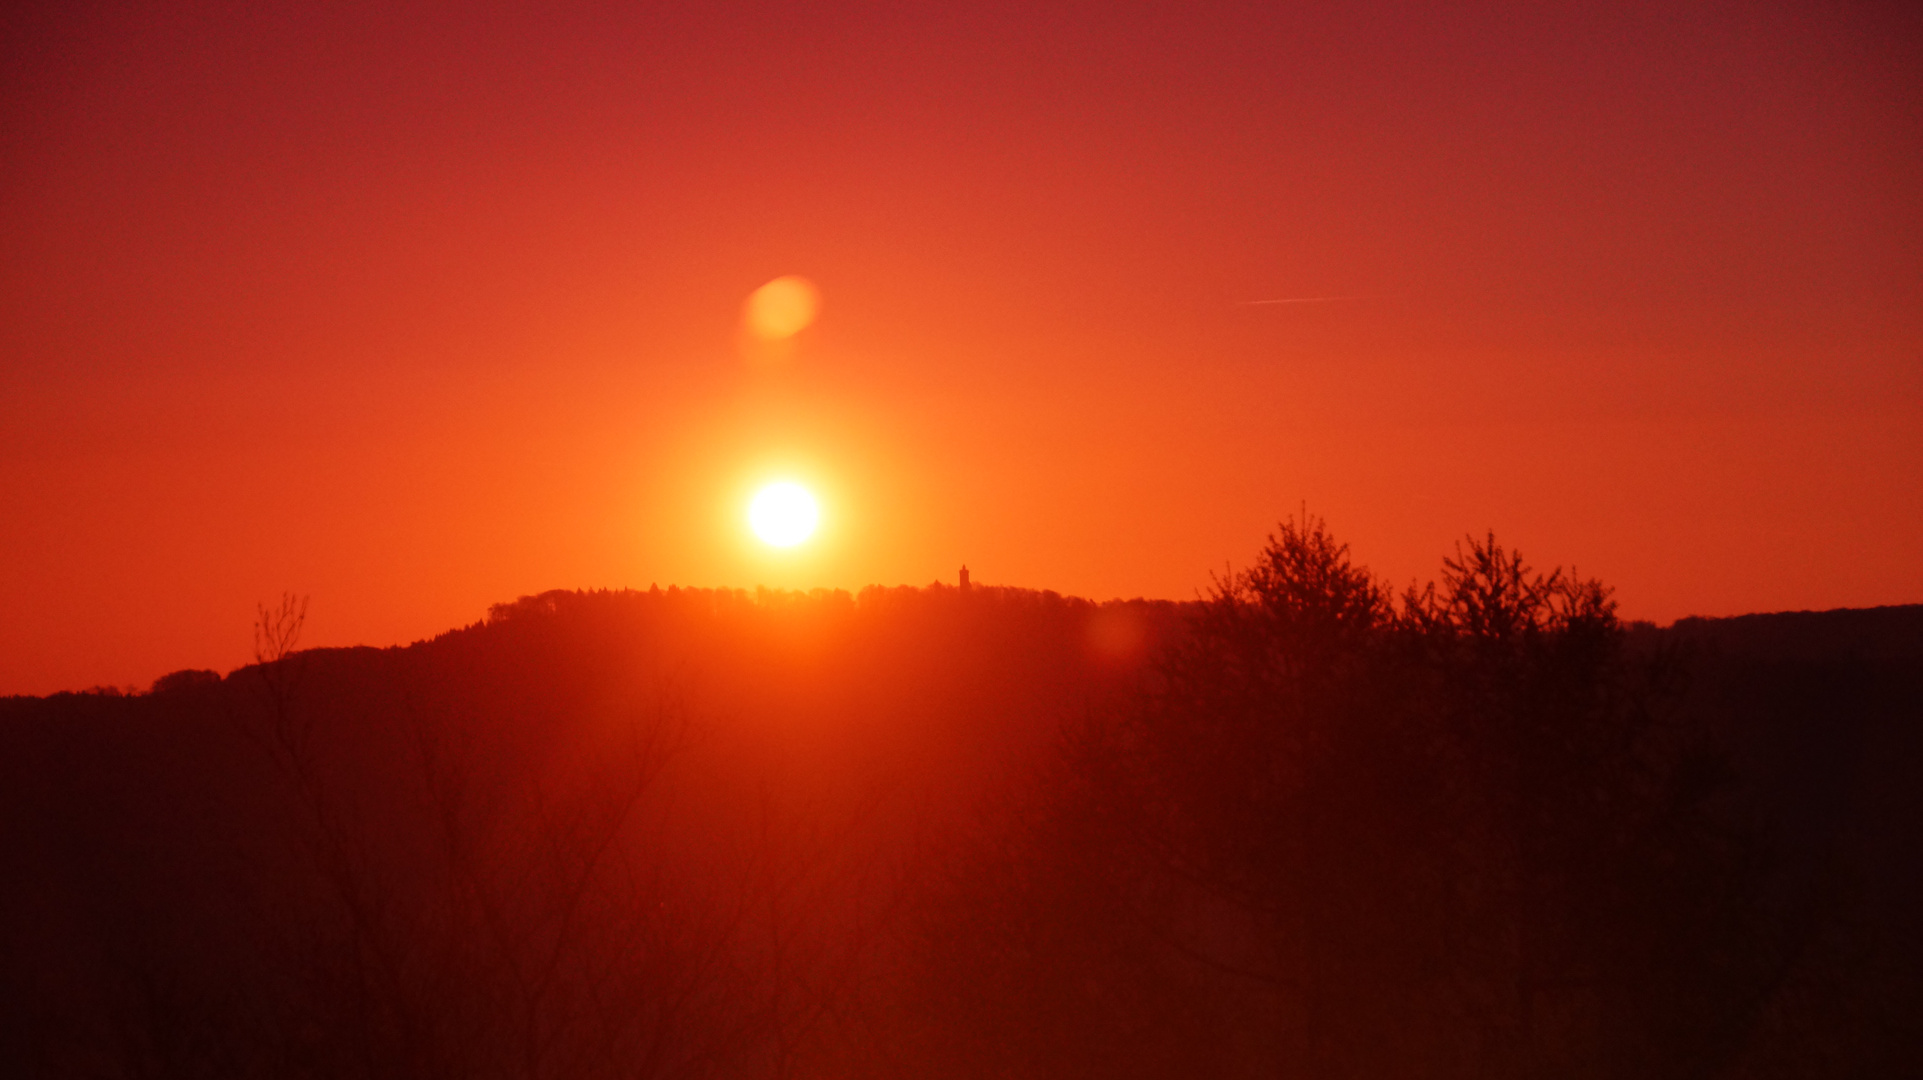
[0,588,1923,1076]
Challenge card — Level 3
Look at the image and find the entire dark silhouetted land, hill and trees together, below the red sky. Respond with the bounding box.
[0,515,1923,1080]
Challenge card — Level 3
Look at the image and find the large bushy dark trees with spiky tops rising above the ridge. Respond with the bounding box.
[907,517,1771,1076]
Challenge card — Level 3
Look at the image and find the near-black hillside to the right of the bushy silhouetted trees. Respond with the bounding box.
[1638,605,1923,1076]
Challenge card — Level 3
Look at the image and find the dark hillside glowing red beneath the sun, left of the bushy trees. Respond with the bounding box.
[0,586,1179,1074]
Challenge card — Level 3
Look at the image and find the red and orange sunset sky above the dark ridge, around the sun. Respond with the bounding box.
[0,2,1923,694]
